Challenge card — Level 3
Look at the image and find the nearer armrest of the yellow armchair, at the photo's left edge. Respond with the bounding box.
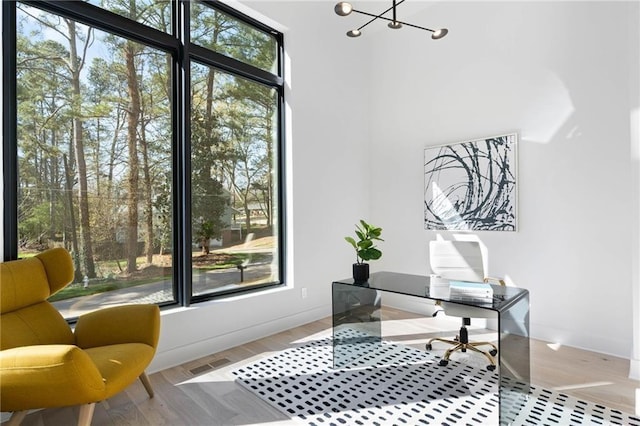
[0,345,105,411]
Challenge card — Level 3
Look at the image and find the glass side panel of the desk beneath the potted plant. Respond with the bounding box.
[332,282,382,368]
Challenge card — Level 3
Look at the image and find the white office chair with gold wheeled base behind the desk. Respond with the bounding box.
[426,240,504,371]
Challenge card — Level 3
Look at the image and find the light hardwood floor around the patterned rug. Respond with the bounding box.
[7,308,640,426]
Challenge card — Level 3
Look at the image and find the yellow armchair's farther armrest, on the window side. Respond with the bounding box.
[75,305,160,348]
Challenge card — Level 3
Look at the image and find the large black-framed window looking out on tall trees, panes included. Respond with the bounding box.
[3,0,284,318]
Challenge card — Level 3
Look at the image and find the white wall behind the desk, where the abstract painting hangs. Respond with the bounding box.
[371,2,639,358]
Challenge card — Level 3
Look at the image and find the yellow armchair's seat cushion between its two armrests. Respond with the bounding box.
[84,343,155,399]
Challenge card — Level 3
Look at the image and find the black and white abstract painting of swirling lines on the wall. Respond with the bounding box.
[424,133,518,231]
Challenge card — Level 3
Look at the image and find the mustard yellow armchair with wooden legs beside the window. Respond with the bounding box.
[0,248,160,425]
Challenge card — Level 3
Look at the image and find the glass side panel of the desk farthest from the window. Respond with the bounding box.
[498,293,531,425]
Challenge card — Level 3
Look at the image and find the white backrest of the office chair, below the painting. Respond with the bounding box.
[429,240,486,282]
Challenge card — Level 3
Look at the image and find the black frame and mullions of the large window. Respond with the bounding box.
[2,0,287,306]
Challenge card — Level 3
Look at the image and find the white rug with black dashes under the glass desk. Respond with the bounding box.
[233,338,640,426]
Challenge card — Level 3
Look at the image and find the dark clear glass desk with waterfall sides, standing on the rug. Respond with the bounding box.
[332,272,530,424]
